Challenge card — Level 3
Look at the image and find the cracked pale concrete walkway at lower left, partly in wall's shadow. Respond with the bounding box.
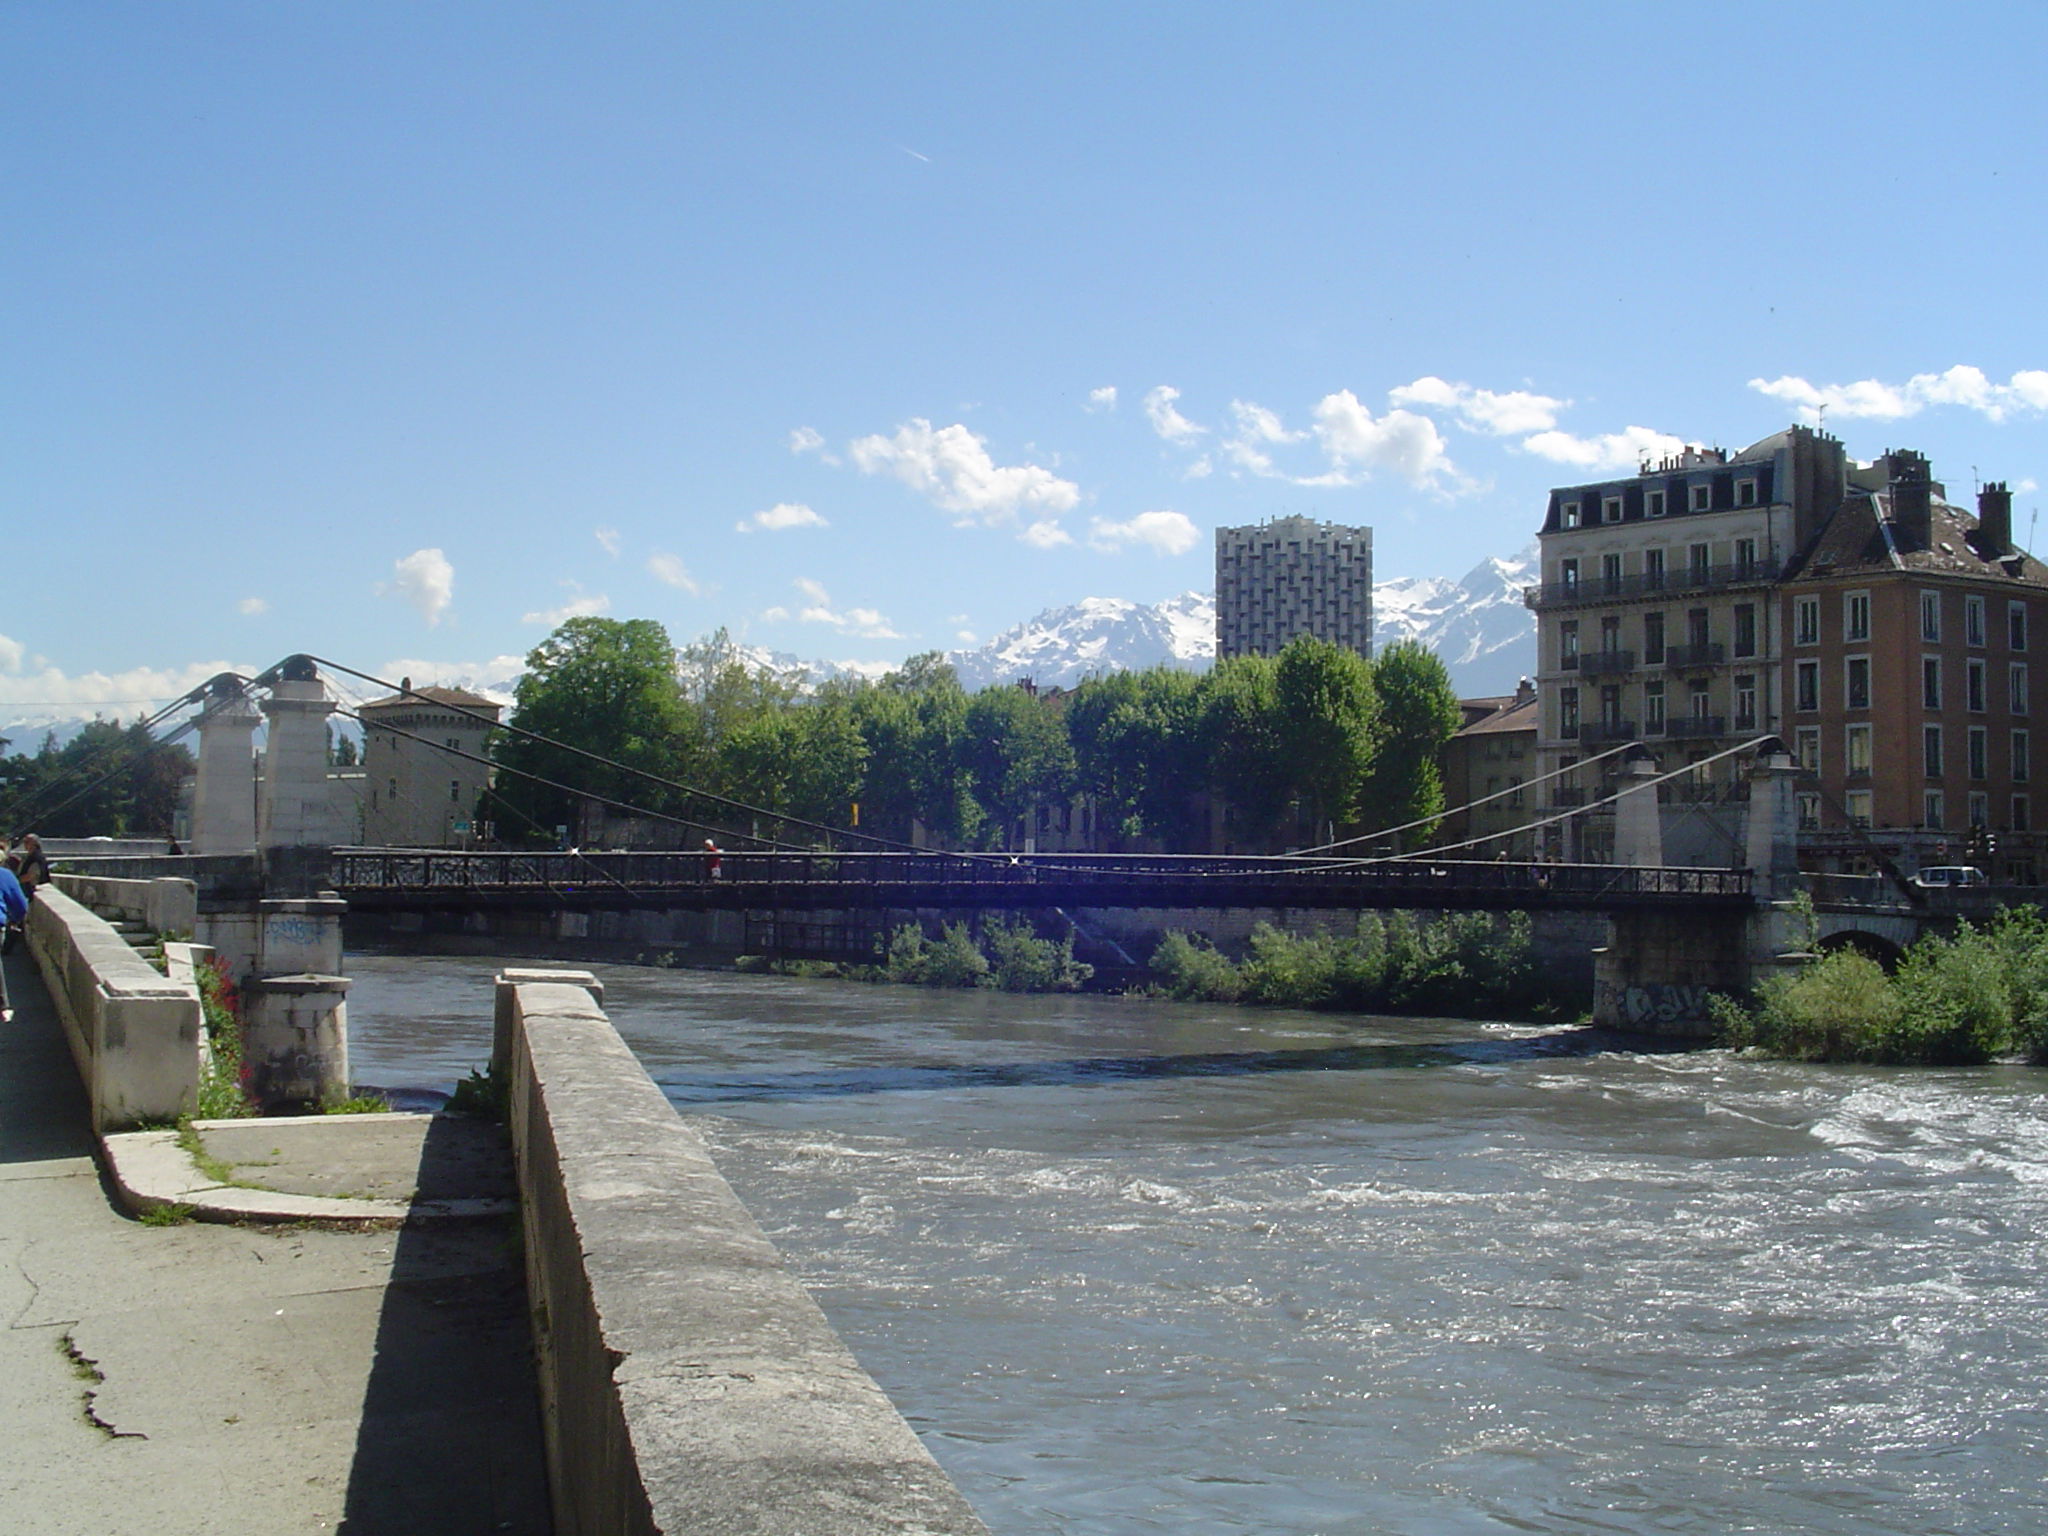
[0,952,549,1536]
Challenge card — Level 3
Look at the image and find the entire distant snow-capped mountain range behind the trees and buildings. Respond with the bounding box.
[0,545,1536,752]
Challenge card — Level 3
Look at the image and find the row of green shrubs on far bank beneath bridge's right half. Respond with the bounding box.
[1151,911,1561,1018]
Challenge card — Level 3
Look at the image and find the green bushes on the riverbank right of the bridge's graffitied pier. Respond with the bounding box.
[1714,907,2048,1067]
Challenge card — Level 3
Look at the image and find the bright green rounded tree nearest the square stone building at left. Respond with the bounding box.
[492,616,705,840]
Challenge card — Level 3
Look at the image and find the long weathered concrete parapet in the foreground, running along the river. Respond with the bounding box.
[496,973,987,1536]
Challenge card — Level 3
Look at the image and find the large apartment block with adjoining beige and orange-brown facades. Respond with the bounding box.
[1526,426,2048,881]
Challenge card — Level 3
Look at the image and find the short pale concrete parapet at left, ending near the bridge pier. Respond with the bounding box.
[29,885,205,1130]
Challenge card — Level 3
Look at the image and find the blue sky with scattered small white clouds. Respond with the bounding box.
[0,0,2048,715]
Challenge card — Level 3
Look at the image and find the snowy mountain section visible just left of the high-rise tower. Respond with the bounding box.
[946,592,1217,690]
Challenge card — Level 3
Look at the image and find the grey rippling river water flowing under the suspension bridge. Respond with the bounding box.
[348,956,2048,1536]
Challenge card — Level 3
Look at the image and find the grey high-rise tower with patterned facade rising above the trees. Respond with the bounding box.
[1217,516,1372,662]
